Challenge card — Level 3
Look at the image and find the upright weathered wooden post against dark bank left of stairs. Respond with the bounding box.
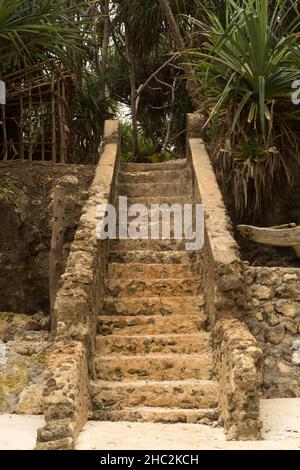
[49,186,65,331]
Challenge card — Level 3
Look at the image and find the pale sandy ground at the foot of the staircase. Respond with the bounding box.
[0,398,300,450]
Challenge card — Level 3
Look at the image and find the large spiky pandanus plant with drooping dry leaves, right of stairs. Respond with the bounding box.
[191,0,300,215]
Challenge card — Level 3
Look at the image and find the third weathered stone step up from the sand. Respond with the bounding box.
[95,353,213,381]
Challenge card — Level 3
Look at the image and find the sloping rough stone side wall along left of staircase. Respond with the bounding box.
[37,121,120,450]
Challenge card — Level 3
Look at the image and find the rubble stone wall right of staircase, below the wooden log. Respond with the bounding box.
[245,266,300,398]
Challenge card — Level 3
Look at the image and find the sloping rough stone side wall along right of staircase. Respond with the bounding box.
[187,115,263,440]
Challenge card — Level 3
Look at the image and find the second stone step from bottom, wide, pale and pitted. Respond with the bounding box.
[91,380,219,410]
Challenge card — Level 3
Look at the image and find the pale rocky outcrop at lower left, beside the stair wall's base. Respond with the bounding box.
[0,313,52,415]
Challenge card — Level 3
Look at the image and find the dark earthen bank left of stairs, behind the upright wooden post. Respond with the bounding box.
[0,161,95,315]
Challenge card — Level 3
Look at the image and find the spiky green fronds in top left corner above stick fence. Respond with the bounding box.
[0,0,87,72]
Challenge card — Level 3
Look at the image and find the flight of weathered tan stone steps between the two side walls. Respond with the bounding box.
[91,160,218,423]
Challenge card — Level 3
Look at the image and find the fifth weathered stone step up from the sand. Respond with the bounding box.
[98,314,205,335]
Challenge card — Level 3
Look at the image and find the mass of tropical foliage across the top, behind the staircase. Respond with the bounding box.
[0,0,300,218]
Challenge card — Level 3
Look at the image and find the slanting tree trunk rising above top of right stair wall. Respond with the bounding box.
[159,0,200,108]
